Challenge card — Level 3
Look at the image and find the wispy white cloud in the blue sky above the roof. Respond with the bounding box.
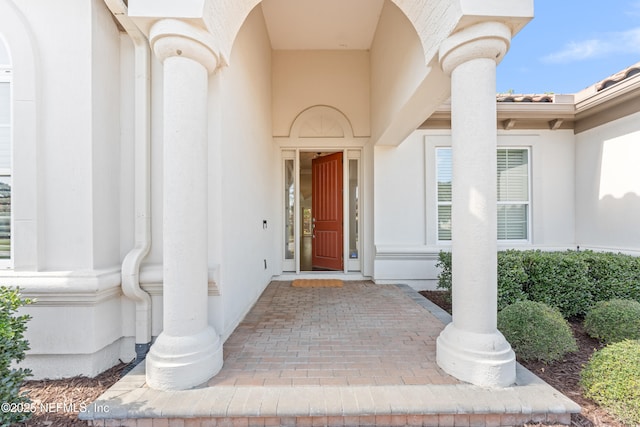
[542,27,640,64]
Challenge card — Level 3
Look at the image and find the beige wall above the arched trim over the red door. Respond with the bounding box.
[273,50,370,136]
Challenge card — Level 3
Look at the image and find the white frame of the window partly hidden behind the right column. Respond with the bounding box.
[434,145,533,245]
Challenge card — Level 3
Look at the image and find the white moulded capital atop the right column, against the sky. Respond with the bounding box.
[439,21,511,75]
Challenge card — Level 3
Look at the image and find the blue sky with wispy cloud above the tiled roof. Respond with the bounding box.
[497,0,640,94]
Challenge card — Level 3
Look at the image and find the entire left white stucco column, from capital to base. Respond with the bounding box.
[146,19,222,390]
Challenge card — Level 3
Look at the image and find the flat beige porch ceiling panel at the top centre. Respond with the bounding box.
[262,0,384,50]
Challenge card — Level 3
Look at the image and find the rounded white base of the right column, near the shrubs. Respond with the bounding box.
[436,323,516,387]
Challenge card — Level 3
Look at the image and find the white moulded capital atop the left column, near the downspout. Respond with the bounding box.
[149,18,220,73]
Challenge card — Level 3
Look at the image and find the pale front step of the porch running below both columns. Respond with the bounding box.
[80,364,580,427]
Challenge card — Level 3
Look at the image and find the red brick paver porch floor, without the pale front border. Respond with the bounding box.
[209,282,458,386]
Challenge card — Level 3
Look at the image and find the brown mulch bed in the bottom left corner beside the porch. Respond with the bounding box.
[18,363,127,427]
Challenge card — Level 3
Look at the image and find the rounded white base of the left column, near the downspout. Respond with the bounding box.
[146,326,222,390]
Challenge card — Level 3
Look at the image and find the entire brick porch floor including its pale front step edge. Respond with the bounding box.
[80,282,580,427]
